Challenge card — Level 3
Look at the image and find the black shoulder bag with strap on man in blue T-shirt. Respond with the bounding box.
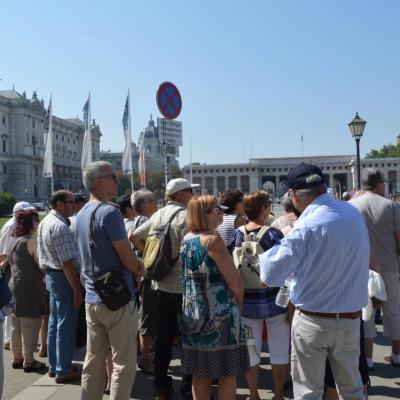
[89,203,132,311]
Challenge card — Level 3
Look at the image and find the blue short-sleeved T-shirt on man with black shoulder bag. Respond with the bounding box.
[76,202,135,304]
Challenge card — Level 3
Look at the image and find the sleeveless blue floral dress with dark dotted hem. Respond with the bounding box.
[180,234,249,379]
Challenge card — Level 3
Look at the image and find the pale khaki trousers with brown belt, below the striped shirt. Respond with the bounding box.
[291,310,365,400]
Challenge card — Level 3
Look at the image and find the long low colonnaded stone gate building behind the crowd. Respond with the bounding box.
[183,155,400,197]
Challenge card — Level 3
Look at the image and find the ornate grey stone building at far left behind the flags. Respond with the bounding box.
[0,89,101,201]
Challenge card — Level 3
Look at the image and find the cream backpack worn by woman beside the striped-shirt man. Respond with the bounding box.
[232,226,269,289]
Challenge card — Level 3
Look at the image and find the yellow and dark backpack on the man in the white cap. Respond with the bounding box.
[143,208,183,281]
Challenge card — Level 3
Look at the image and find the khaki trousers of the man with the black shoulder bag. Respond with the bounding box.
[81,301,137,400]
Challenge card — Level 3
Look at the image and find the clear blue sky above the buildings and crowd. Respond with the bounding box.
[0,0,400,166]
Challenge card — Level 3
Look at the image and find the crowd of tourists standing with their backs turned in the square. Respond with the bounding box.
[0,161,400,400]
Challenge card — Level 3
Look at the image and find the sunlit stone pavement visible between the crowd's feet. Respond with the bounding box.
[4,326,400,400]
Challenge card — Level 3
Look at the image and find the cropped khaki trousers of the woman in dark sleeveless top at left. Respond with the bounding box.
[11,314,42,354]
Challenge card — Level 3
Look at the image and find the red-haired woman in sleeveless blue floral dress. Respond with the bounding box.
[180,195,249,400]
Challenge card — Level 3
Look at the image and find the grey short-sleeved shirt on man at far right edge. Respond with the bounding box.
[350,192,400,273]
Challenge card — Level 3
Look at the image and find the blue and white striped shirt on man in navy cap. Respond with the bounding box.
[260,194,369,313]
